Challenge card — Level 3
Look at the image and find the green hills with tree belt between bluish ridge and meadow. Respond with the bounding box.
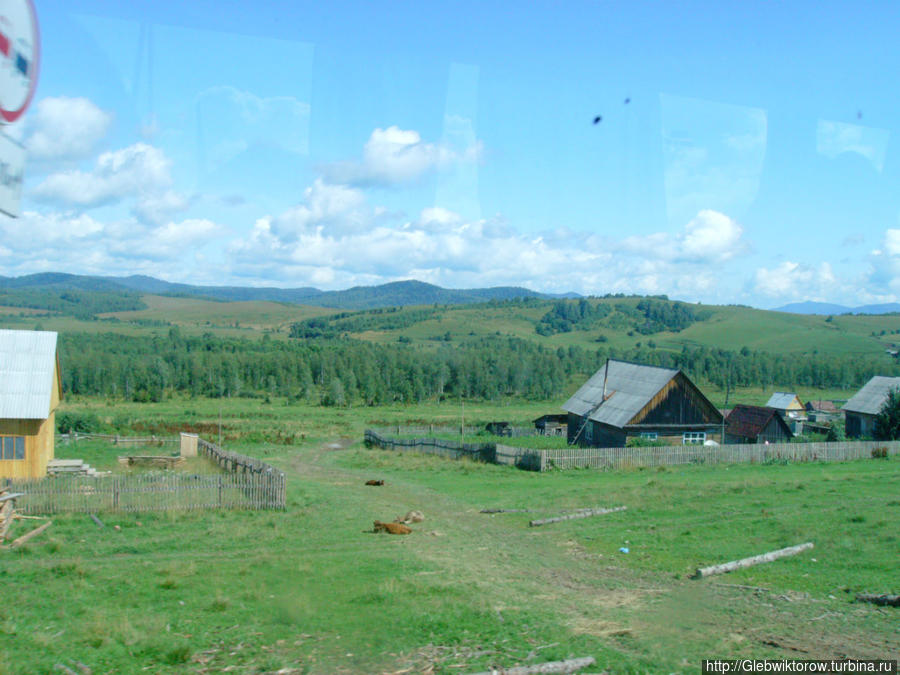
[0,288,900,405]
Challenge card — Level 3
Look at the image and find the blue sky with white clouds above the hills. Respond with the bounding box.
[0,0,900,307]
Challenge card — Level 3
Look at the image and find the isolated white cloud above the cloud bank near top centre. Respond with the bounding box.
[324,126,481,186]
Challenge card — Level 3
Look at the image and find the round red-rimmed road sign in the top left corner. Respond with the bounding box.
[0,0,41,124]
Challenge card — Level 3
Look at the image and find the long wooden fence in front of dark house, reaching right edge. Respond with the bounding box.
[365,429,900,471]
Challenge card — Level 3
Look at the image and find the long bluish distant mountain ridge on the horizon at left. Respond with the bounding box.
[0,272,581,309]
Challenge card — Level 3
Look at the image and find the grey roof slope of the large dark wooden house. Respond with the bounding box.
[563,359,678,427]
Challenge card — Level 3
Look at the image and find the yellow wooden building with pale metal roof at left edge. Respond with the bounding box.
[0,330,62,478]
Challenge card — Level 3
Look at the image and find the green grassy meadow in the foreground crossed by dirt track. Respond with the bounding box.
[0,400,900,674]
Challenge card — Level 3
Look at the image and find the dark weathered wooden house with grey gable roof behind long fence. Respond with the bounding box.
[563,359,723,448]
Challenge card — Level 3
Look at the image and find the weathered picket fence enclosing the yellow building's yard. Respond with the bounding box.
[5,439,286,514]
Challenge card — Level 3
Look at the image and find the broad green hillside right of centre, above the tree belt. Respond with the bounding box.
[284,297,900,355]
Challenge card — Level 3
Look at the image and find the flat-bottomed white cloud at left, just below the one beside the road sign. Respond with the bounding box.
[32,143,172,207]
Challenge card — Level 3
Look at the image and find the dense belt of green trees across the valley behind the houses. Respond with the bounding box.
[60,327,900,405]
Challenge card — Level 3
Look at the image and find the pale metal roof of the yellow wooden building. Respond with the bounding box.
[0,330,56,420]
